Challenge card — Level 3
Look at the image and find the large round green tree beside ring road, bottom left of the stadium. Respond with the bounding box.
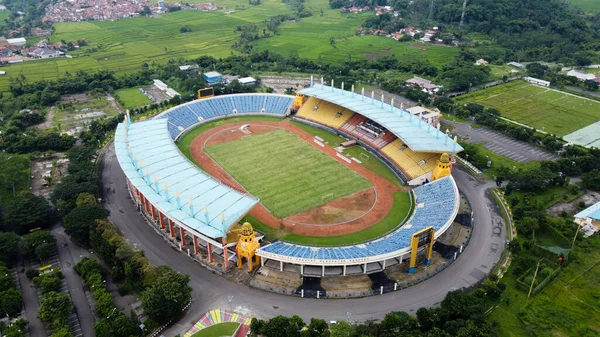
[142,271,192,324]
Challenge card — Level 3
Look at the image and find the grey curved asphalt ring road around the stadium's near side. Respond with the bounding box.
[102,145,505,336]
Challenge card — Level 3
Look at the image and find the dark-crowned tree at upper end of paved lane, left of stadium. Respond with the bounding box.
[64,204,108,247]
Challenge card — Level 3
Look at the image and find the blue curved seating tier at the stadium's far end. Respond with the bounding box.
[158,94,294,139]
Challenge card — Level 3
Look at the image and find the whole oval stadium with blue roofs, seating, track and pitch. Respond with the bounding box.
[115,80,462,277]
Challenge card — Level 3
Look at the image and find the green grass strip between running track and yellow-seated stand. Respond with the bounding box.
[292,121,403,186]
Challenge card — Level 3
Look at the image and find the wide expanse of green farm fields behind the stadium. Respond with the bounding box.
[0,0,458,92]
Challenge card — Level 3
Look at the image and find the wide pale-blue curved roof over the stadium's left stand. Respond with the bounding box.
[115,119,258,238]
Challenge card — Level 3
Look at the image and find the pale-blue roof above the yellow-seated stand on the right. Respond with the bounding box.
[298,84,463,153]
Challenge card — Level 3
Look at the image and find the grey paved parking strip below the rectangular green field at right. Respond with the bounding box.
[444,121,558,163]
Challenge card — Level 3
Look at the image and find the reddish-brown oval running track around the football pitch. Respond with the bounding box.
[190,120,400,236]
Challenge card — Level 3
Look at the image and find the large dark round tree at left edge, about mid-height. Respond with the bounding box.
[4,193,52,234]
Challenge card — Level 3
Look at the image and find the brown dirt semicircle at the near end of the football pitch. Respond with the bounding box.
[285,188,377,225]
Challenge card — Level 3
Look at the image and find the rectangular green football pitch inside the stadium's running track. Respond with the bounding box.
[205,130,372,218]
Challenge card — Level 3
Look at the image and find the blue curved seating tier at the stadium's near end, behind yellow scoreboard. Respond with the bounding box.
[260,176,458,260]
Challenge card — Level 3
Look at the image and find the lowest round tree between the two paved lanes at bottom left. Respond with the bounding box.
[38,291,73,330]
